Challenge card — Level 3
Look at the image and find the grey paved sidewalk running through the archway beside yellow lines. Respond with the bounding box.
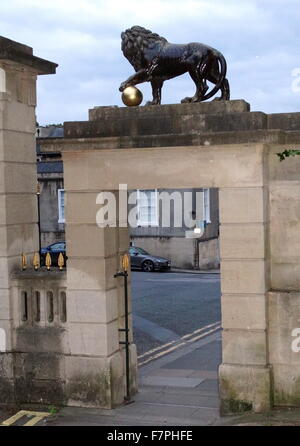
[47,331,225,426]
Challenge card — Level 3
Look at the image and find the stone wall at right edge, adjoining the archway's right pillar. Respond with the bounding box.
[268,144,300,406]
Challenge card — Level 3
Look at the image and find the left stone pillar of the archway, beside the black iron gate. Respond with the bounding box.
[64,182,136,409]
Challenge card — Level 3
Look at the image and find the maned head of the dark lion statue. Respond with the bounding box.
[121,26,167,71]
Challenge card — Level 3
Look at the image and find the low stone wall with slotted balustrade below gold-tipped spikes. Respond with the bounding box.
[11,271,69,405]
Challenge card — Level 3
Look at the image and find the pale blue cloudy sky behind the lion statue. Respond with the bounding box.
[0,0,300,125]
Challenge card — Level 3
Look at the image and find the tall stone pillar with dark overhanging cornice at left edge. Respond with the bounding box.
[0,37,57,402]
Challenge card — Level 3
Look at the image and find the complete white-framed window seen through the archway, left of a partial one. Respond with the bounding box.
[137,189,158,226]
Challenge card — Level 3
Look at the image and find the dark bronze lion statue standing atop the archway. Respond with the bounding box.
[119,26,230,105]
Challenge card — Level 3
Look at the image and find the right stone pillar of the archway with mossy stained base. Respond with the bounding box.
[219,187,271,414]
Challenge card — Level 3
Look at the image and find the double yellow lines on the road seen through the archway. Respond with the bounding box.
[138,322,221,366]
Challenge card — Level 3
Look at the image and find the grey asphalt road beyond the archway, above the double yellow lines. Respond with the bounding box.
[132,271,221,355]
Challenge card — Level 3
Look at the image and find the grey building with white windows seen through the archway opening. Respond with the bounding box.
[130,189,220,269]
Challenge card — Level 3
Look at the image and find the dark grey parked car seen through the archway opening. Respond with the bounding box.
[129,246,171,272]
